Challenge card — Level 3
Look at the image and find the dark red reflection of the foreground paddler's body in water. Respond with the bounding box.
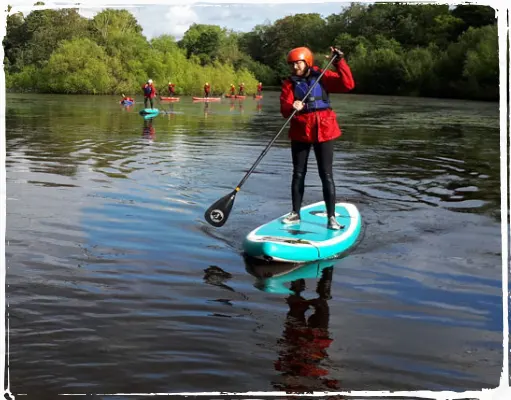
[274,267,339,392]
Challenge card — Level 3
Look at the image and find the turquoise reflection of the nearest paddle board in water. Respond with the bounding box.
[246,259,339,294]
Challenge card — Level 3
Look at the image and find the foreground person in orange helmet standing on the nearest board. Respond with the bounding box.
[280,47,355,230]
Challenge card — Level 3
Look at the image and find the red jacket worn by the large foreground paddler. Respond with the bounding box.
[280,59,355,143]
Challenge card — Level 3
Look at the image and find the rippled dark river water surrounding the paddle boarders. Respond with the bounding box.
[5,92,502,399]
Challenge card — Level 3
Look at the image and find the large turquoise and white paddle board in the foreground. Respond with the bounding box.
[243,201,362,263]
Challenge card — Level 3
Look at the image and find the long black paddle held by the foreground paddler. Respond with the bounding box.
[204,53,337,228]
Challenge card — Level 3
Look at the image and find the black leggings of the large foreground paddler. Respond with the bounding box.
[291,140,335,217]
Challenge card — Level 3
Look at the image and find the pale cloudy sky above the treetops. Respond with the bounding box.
[9,0,349,40]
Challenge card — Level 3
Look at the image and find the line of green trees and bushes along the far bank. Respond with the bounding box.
[3,3,499,101]
